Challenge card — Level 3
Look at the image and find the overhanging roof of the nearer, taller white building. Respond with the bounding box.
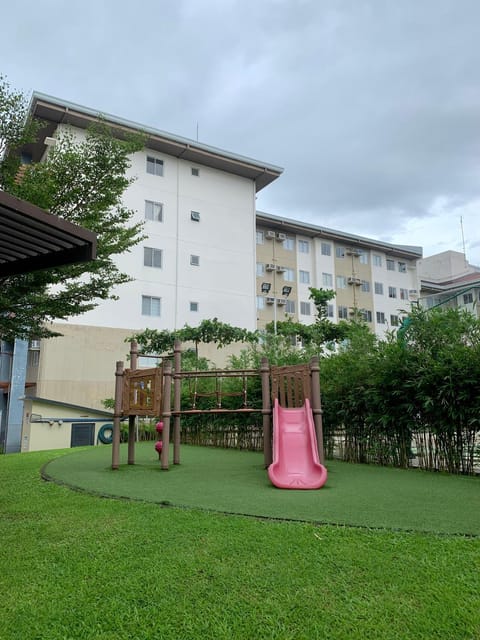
[28,92,283,191]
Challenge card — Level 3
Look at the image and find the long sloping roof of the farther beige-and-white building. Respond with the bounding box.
[257,211,423,260]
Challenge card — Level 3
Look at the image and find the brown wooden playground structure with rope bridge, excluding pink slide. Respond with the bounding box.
[112,341,324,470]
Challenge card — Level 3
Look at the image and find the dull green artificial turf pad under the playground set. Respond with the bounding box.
[44,443,480,535]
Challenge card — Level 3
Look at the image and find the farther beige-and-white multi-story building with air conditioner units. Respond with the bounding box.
[256,212,422,336]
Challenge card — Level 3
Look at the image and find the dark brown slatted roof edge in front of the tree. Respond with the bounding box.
[0,191,97,277]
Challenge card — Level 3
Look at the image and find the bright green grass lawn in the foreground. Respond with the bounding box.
[0,452,480,640]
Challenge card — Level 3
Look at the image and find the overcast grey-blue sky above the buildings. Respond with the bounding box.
[0,0,480,265]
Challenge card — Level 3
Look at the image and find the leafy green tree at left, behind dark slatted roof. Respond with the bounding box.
[0,78,144,340]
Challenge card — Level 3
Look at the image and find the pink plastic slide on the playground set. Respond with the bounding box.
[268,399,327,489]
